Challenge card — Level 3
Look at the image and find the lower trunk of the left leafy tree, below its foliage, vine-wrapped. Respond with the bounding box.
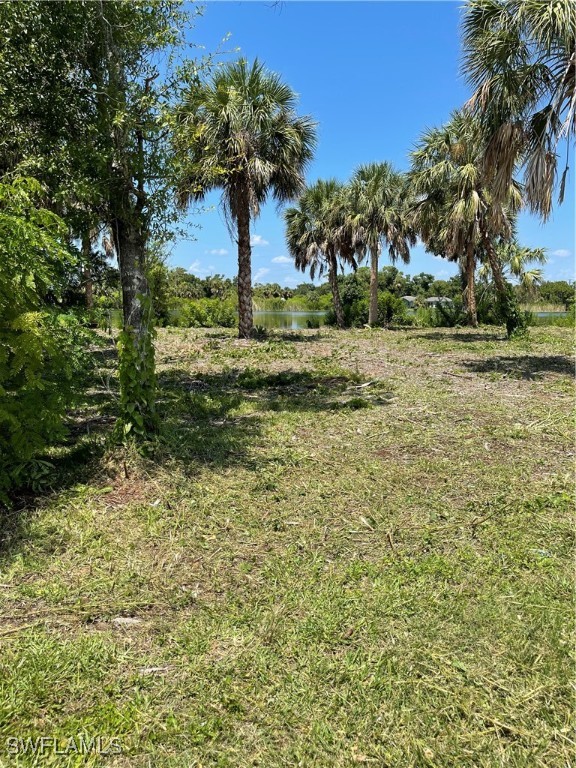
[113,218,158,436]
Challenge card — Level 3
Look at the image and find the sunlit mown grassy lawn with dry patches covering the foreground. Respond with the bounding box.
[0,328,574,768]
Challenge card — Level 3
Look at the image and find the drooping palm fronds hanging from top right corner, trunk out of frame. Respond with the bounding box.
[463,0,576,219]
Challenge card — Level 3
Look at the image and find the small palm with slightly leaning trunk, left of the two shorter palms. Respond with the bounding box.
[284,179,357,328]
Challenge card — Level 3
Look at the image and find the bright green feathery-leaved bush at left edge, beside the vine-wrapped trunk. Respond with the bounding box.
[0,179,88,501]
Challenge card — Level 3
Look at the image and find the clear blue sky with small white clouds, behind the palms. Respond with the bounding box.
[170,0,575,286]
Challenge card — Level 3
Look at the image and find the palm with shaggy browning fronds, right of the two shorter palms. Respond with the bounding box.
[410,112,521,326]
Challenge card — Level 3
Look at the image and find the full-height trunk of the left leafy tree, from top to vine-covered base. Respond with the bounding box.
[95,2,158,438]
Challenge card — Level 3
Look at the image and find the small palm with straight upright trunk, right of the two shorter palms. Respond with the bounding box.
[350,163,416,325]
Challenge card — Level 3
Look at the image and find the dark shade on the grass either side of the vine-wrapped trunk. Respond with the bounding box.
[0,358,389,561]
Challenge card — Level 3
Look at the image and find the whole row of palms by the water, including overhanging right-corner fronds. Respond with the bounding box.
[175,0,576,337]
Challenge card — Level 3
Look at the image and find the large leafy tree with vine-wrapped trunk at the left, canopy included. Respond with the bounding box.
[0,0,198,435]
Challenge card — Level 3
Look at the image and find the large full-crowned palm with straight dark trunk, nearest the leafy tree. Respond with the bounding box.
[175,59,316,338]
